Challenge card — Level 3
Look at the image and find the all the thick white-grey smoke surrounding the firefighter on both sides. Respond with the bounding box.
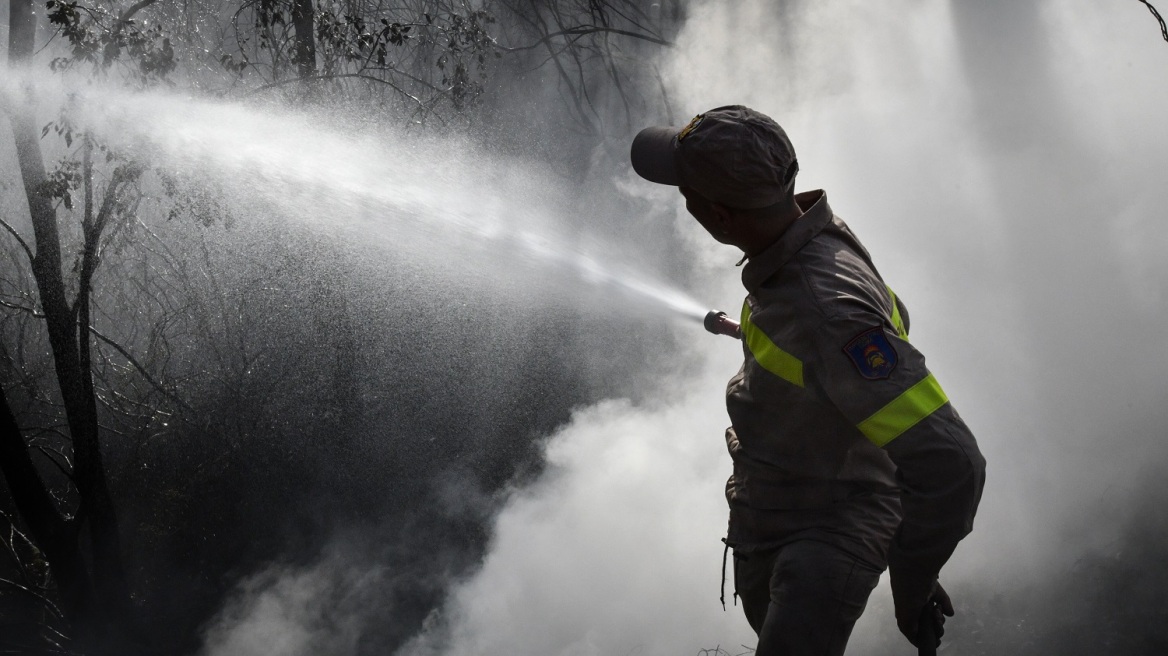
[193,0,1168,656]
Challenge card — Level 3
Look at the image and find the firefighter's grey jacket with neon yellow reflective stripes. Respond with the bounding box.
[726,190,985,577]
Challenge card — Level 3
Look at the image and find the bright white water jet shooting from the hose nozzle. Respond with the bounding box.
[0,78,742,339]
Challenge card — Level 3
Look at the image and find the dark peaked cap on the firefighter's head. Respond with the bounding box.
[630,105,799,209]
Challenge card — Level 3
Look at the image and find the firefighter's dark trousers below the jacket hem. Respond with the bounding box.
[735,539,881,656]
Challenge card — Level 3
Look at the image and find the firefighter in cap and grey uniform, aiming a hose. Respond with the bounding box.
[631,105,985,656]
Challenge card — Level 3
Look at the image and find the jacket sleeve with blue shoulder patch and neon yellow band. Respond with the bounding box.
[815,313,986,590]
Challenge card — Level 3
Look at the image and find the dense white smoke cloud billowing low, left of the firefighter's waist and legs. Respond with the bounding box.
[403,364,742,655]
